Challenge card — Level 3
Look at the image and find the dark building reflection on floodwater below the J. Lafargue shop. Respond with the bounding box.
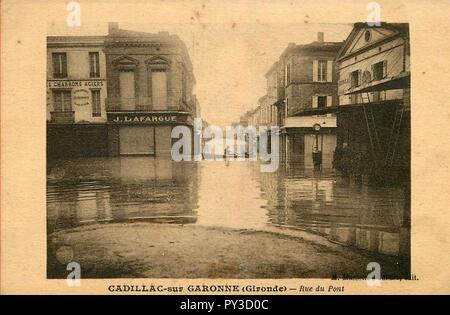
[47,157,198,232]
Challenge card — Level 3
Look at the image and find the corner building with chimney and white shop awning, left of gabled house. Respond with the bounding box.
[272,33,342,168]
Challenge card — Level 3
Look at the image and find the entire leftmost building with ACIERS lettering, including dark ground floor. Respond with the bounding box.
[46,36,107,160]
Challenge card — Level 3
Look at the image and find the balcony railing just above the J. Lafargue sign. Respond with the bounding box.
[105,96,195,112]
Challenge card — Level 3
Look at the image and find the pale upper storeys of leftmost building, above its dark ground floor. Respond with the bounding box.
[47,36,107,124]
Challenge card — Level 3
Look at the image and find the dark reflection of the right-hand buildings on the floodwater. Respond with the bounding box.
[253,164,409,258]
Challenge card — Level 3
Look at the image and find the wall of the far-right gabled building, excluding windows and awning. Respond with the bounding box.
[337,24,411,174]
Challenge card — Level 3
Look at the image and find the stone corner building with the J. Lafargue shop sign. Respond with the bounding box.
[105,23,198,156]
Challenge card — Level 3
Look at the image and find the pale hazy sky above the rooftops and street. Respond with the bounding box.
[48,20,352,126]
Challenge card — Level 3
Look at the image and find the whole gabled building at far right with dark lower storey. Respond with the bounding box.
[337,23,411,175]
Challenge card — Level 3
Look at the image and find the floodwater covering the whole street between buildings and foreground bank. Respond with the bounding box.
[47,157,409,257]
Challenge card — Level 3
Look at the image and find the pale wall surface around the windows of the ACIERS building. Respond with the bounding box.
[47,41,107,123]
